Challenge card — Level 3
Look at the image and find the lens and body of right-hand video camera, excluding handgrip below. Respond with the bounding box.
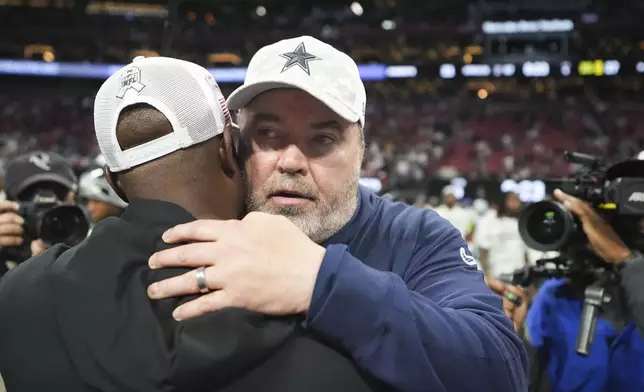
[519,152,644,252]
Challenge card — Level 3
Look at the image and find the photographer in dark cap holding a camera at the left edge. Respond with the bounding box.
[0,152,82,276]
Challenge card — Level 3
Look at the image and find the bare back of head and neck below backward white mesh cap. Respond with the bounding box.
[115,104,243,219]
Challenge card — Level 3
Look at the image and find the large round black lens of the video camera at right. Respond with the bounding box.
[519,200,578,252]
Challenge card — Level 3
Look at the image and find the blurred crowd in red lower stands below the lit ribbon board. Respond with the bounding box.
[0,80,644,188]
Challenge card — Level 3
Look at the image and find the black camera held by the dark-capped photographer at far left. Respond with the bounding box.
[18,189,89,246]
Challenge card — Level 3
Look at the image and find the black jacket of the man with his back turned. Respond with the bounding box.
[0,201,387,392]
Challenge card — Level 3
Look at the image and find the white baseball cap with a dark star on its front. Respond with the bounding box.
[228,36,367,126]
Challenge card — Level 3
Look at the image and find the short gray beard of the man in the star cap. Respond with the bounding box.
[245,179,358,244]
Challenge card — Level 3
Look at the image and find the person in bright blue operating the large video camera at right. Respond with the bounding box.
[526,190,644,392]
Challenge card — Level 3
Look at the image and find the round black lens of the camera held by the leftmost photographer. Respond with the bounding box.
[40,206,89,246]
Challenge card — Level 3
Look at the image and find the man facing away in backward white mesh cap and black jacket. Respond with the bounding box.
[0,57,385,392]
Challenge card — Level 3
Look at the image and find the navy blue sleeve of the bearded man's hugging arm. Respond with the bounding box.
[307,220,528,392]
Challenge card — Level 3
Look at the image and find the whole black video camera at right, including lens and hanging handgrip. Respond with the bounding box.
[499,152,644,356]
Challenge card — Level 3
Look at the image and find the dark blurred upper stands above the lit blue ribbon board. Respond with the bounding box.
[0,0,641,65]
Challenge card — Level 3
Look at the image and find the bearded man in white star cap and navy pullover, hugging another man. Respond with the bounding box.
[149,36,527,392]
